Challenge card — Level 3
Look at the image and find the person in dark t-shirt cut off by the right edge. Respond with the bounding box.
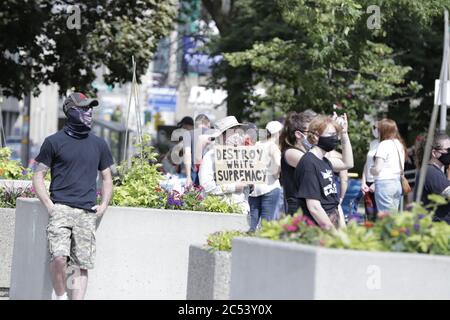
[414,133,450,224]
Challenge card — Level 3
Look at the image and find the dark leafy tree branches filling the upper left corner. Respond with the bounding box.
[0,0,177,98]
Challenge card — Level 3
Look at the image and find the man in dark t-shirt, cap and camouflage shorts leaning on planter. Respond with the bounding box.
[33,93,113,300]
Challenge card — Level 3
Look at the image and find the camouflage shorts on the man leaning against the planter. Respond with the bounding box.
[47,204,97,269]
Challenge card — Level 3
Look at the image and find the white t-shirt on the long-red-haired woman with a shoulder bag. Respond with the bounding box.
[375,139,405,180]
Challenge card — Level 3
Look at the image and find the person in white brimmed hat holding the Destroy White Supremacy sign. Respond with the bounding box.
[199,116,250,213]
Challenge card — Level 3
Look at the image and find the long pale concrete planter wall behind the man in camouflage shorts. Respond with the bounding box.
[10,199,248,299]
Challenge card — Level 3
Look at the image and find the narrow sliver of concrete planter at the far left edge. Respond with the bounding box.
[0,208,15,289]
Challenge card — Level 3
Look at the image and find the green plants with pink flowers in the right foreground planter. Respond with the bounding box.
[256,196,450,255]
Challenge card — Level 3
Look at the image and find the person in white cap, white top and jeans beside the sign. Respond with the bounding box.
[248,121,283,232]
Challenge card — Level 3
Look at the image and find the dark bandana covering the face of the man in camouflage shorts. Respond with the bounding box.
[64,107,92,139]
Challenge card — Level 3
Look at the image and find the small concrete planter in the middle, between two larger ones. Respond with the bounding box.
[187,245,231,300]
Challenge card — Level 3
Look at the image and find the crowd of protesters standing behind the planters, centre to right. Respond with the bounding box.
[166,109,450,231]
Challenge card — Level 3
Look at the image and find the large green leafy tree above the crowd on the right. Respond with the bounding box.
[205,0,448,170]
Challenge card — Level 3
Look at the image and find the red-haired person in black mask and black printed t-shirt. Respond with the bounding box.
[295,114,353,230]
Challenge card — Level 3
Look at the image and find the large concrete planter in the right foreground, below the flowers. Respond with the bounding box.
[230,238,450,300]
